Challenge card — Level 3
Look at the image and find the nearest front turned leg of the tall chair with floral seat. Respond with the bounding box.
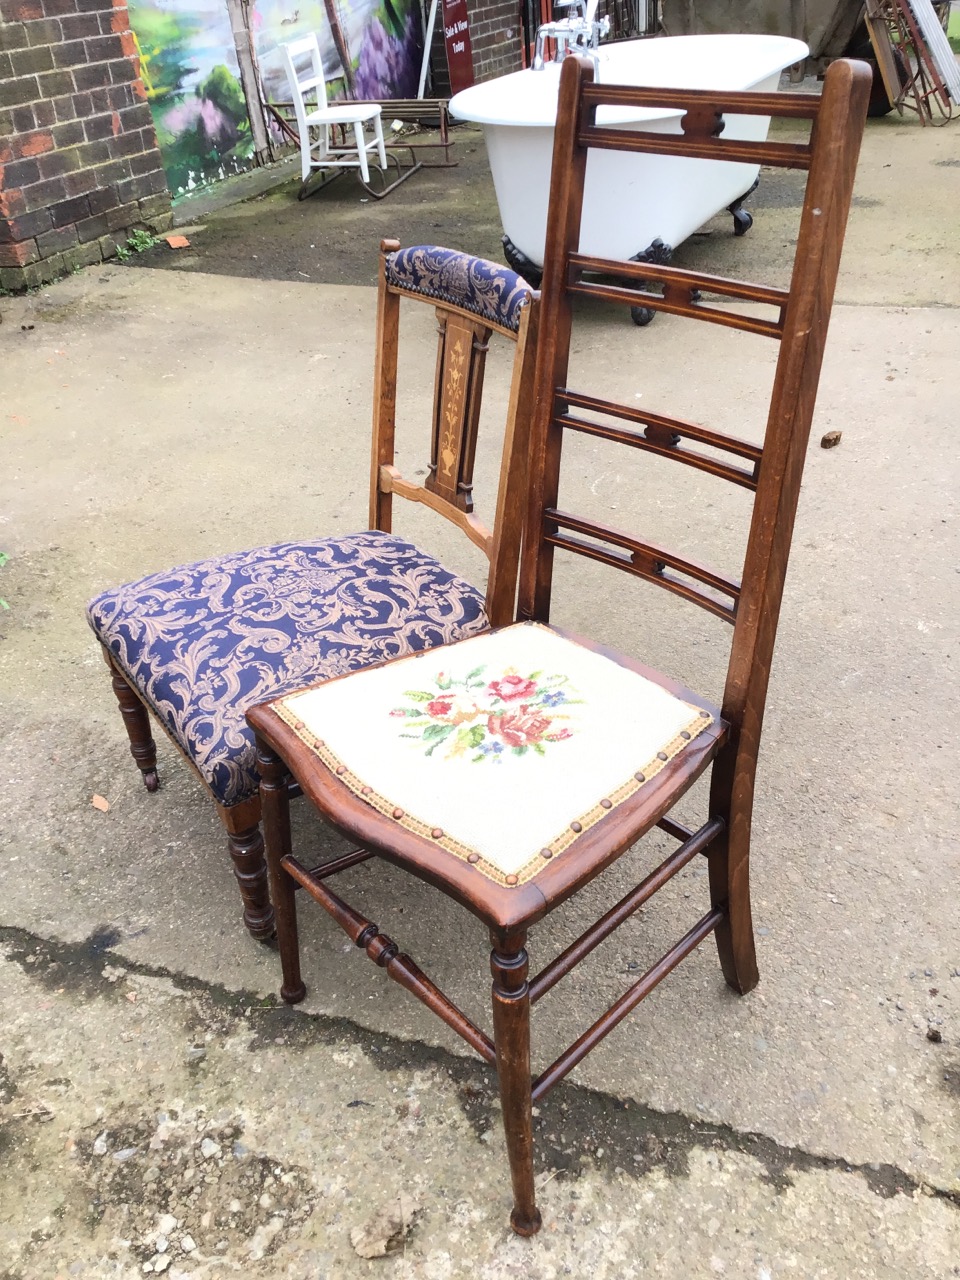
[490,934,541,1235]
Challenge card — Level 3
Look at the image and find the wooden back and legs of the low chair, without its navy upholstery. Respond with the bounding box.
[102,239,539,940]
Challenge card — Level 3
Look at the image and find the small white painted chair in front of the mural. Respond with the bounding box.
[280,33,387,183]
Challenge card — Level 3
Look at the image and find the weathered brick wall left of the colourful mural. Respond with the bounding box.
[0,0,172,289]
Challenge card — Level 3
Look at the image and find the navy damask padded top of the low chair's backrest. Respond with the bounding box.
[387,244,534,333]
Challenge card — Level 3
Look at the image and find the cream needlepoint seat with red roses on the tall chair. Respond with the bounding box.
[256,623,723,924]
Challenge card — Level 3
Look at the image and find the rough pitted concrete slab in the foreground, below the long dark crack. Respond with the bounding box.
[0,929,960,1280]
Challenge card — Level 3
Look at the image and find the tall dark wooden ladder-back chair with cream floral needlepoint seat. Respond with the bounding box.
[248,58,870,1235]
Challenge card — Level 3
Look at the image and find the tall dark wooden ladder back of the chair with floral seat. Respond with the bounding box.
[518,58,870,757]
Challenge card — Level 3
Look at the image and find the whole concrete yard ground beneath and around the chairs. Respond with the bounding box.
[0,102,960,1280]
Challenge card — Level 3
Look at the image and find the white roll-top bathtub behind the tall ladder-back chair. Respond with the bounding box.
[451,36,808,266]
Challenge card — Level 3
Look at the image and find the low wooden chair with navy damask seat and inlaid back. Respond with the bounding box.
[87,241,539,938]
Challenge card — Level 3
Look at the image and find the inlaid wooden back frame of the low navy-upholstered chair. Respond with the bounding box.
[370,241,539,626]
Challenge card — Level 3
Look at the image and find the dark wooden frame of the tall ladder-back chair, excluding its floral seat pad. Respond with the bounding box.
[248,58,872,1235]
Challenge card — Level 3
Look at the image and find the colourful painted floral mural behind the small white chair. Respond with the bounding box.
[129,0,422,196]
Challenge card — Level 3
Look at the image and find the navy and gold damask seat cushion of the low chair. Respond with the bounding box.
[87,531,488,805]
